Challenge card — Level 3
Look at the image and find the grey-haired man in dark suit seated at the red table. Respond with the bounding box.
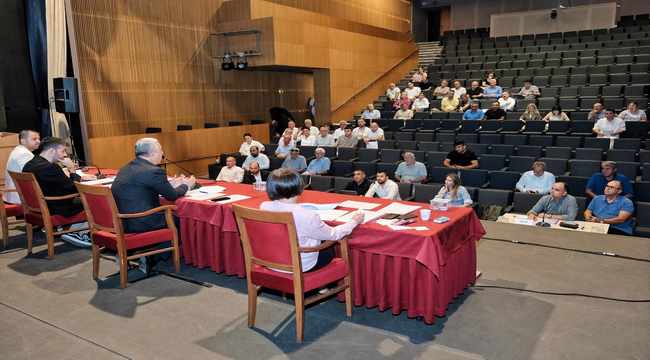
[111,138,196,233]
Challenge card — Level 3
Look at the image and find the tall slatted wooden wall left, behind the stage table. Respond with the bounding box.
[71,0,313,138]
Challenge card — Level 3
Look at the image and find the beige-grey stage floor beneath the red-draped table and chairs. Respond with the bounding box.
[0,223,650,360]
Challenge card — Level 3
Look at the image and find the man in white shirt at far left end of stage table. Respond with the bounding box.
[2,130,41,204]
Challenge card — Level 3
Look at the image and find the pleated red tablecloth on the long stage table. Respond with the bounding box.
[176,183,485,323]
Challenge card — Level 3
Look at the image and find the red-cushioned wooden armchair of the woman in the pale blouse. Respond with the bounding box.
[233,205,352,342]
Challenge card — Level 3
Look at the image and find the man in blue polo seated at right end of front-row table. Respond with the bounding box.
[585,180,634,235]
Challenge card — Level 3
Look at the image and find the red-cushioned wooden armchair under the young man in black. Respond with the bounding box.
[9,171,87,259]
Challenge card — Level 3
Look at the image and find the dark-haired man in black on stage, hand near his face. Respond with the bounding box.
[23,137,91,246]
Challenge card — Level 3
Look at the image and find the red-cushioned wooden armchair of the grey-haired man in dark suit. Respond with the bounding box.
[75,183,181,289]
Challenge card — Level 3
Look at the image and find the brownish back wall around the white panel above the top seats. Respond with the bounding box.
[451,0,650,30]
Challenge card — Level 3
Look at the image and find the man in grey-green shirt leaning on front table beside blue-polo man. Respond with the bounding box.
[528,181,578,221]
